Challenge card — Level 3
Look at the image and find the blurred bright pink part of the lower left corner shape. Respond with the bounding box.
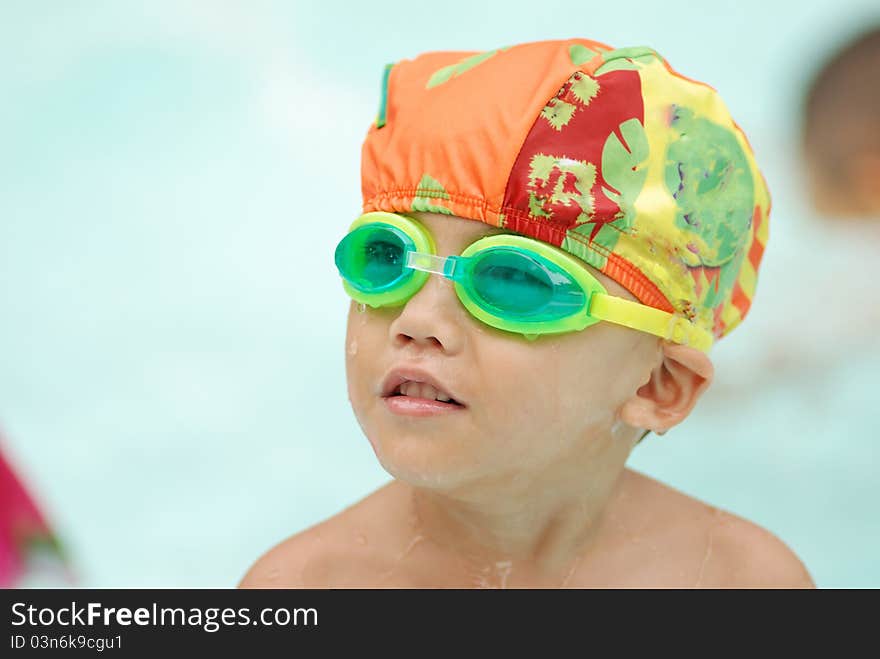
[0,444,63,588]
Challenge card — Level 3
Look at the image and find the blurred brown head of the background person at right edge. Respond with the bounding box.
[802,27,880,217]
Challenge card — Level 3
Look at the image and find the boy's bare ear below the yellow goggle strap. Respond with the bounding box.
[619,341,715,433]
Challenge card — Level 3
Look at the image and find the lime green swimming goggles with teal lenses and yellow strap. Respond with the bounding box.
[335,212,712,351]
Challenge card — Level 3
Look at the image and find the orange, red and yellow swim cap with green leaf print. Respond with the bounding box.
[361,39,770,348]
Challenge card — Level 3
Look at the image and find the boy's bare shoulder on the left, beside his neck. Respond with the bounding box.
[238,481,406,588]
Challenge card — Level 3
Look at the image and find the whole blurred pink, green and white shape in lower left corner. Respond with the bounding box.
[0,438,72,588]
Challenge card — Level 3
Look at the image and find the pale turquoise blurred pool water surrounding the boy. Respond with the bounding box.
[0,0,880,587]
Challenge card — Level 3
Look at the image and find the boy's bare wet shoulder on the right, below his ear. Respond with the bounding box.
[626,469,815,588]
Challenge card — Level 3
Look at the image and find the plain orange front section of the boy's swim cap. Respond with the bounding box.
[361,39,610,226]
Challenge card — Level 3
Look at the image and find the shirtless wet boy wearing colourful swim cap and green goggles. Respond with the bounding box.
[240,39,812,588]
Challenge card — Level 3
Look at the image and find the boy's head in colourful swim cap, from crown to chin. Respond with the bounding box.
[337,39,769,480]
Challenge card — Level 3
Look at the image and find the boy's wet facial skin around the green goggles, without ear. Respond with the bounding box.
[346,213,658,489]
